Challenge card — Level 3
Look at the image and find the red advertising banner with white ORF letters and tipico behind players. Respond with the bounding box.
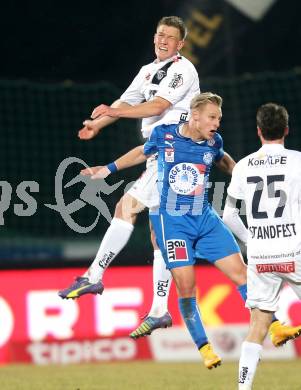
[0,266,300,364]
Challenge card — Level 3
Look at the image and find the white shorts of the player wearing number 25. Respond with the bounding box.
[246,259,301,312]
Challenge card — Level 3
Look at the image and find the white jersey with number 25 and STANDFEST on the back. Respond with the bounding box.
[228,144,301,266]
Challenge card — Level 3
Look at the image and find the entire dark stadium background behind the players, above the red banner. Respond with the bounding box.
[0,0,301,268]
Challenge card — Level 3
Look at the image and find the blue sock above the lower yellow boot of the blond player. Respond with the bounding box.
[178,297,208,349]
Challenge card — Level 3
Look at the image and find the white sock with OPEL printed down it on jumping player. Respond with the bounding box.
[149,249,172,317]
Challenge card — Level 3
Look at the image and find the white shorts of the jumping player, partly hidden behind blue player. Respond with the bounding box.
[127,156,159,209]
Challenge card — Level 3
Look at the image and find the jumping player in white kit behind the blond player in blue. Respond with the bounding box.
[59,16,199,337]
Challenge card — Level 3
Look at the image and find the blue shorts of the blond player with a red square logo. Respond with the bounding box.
[150,206,240,269]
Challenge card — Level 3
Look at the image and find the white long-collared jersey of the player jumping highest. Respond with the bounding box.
[120,55,200,138]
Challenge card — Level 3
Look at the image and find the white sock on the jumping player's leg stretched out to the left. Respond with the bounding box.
[84,218,134,283]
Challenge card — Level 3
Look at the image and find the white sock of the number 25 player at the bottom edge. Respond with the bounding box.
[238,341,262,390]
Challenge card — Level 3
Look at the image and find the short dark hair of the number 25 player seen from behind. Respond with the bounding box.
[256,103,288,141]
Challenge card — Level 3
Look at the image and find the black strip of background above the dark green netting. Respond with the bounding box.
[0,0,301,84]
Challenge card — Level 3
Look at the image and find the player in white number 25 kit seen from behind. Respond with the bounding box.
[224,103,301,390]
